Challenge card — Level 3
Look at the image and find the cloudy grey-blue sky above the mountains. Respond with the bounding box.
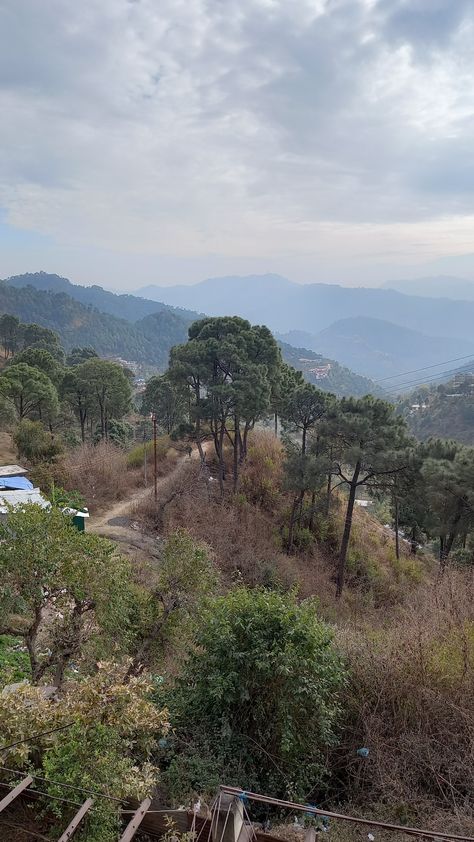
[0,0,474,289]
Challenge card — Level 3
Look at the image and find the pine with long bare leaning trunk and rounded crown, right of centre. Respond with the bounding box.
[324,396,412,596]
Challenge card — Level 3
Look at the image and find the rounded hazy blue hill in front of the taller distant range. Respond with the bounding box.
[282,316,474,378]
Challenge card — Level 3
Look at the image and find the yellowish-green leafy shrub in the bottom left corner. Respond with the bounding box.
[0,663,167,842]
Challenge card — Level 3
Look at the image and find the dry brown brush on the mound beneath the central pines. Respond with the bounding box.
[134,432,430,618]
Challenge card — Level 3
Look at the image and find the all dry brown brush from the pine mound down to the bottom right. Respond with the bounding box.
[131,434,474,842]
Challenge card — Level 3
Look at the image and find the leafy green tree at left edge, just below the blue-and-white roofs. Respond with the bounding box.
[0,504,130,686]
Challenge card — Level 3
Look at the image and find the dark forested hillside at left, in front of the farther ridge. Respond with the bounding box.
[0,282,189,368]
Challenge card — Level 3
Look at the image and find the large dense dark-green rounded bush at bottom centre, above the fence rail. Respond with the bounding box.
[162,588,345,798]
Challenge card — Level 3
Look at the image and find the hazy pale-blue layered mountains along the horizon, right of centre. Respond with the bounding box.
[135,275,474,379]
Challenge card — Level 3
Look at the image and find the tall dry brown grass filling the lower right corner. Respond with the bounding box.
[338,571,474,826]
